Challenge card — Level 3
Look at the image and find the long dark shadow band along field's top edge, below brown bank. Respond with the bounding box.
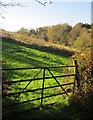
[2,37,74,57]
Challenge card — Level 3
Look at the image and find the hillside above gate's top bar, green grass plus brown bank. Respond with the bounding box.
[2,30,77,67]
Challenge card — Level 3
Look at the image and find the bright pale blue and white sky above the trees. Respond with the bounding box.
[0,0,91,31]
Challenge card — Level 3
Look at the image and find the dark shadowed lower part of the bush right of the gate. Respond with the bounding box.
[70,82,93,119]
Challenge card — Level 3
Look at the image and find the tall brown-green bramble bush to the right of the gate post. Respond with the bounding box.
[70,50,93,119]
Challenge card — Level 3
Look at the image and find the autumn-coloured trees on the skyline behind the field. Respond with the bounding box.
[17,23,91,49]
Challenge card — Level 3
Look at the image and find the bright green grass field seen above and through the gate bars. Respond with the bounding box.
[2,38,74,118]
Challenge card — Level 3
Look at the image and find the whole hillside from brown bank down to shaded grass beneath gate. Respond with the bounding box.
[0,30,92,120]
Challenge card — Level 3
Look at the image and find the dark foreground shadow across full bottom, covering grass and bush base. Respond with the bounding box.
[2,87,93,120]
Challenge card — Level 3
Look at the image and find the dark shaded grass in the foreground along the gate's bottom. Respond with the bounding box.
[2,100,88,120]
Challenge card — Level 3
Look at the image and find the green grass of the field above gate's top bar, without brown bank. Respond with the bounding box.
[2,38,73,68]
